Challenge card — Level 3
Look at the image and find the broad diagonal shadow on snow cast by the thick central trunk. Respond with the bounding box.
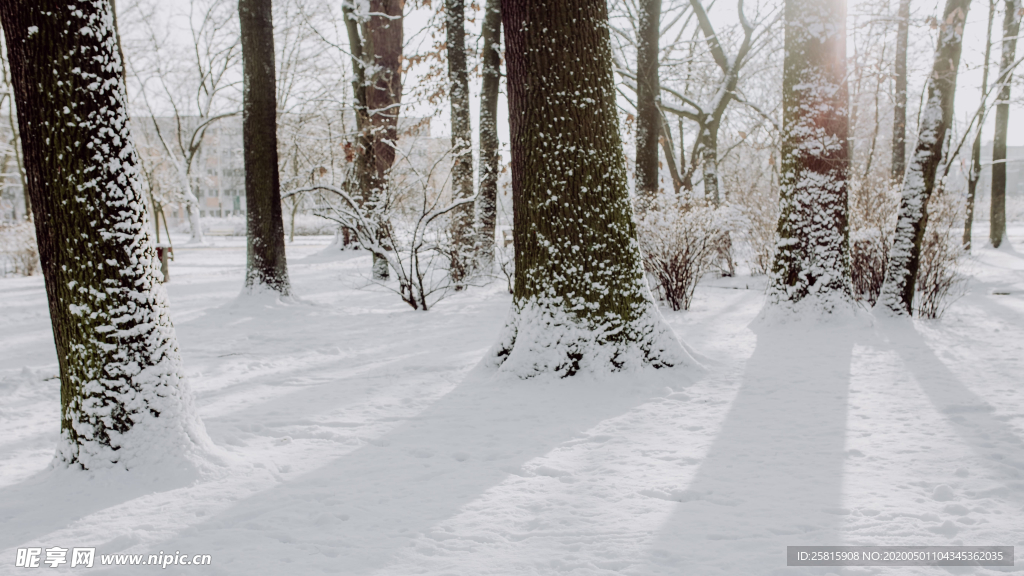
[121,362,687,575]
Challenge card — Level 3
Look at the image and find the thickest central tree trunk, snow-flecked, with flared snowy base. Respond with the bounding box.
[492,0,691,377]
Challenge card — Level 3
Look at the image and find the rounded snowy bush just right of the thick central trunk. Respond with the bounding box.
[637,199,729,311]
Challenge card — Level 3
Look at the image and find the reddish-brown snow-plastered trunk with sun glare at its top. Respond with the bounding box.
[768,0,852,314]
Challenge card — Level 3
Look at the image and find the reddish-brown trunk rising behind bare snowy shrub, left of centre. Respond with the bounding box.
[362,0,406,280]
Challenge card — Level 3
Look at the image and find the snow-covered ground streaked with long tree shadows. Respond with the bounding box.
[0,227,1024,576]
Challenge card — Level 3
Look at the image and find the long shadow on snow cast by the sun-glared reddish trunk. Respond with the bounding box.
[645,325,855,576]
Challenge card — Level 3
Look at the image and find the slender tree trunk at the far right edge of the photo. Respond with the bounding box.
[988,0,1024,248]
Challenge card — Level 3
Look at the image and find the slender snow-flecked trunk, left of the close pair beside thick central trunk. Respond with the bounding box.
[444,0,475,282]
